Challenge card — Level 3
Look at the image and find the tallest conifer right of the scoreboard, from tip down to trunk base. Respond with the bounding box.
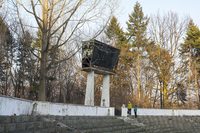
[127,2,149,104]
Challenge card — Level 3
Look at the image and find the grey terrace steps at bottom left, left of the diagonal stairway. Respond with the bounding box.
[0,116,69,133]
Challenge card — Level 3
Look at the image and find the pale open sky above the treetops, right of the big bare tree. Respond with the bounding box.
[115,0,200,28]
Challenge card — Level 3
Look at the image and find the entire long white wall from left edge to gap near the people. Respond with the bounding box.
[0,95,114,116]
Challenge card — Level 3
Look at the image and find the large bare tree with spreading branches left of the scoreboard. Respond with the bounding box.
[16,0,116,101]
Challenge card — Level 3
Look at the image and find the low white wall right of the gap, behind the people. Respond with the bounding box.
[122,108,200,116]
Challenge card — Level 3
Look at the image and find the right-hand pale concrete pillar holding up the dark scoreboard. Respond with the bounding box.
[101,74,110,107]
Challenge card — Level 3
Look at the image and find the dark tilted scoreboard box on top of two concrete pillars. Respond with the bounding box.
[82,40,120,74]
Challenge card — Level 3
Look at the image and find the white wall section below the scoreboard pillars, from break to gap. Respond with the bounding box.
[34,102,114,116]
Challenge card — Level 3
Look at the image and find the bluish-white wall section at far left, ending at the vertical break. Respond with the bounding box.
[0,95,32,115]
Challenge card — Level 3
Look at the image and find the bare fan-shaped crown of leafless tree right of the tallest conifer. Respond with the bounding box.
[149,11,189,58]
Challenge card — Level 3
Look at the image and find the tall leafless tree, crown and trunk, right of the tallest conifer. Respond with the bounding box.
[148,12,189,107]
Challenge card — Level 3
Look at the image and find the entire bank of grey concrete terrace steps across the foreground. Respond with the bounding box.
[0,116,200,133]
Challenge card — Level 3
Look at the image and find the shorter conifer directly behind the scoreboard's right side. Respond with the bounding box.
[105,16,130,109]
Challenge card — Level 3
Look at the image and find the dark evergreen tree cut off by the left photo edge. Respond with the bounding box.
[0,17,15,95]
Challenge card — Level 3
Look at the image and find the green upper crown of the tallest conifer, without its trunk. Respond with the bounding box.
[127,2,149,47]
